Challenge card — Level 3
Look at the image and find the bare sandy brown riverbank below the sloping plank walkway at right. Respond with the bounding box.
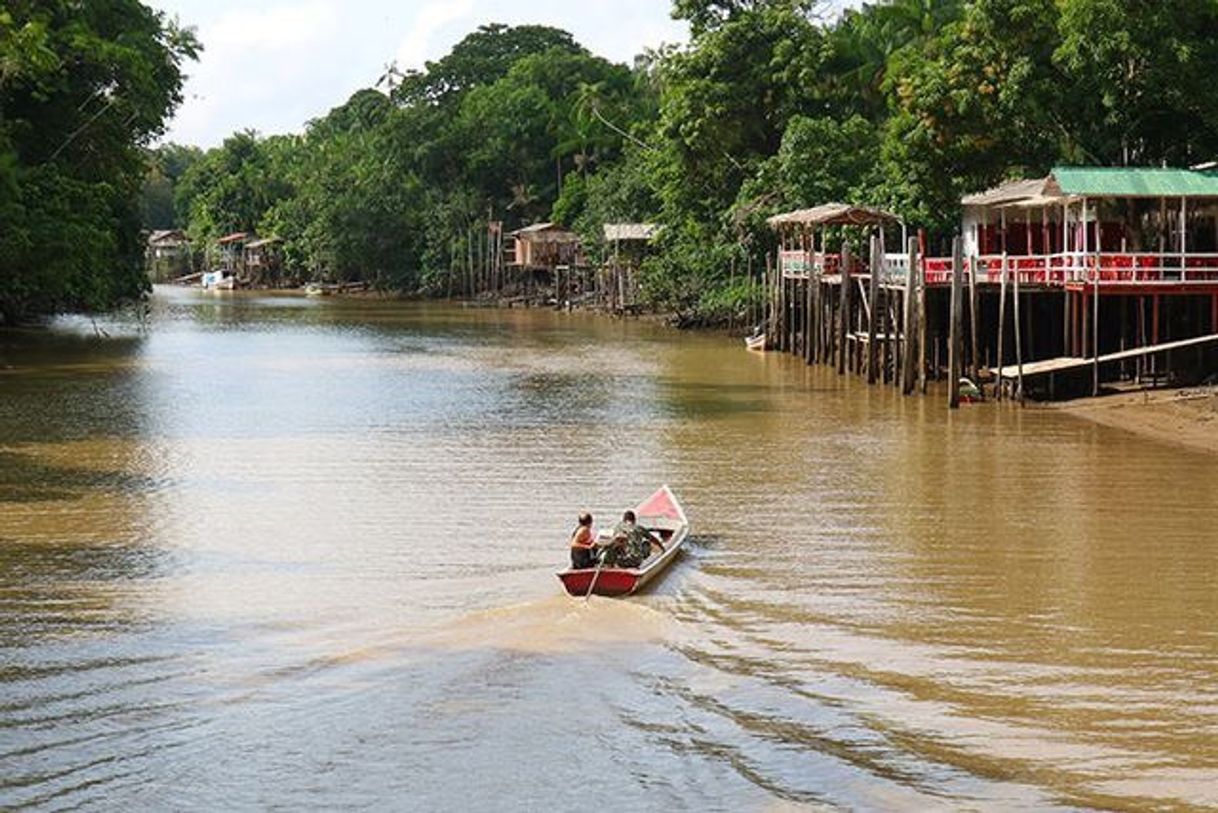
[1047,386,1218,455]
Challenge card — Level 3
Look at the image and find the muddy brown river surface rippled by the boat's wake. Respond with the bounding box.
[0,290,1218,811]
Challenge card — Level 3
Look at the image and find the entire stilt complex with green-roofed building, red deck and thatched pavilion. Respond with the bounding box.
[770,167,1218,406]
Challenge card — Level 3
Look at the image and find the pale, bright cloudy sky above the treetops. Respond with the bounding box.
[145,0,688,147]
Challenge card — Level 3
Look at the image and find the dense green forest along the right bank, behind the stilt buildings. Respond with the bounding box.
[135,0,1218,325]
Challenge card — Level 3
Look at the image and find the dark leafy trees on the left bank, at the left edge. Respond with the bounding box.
[0,0,197,323]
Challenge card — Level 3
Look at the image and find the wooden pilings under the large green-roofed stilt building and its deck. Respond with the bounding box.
[766,236,1218,407]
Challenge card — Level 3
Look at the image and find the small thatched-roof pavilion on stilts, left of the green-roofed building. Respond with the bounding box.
[767,204,904,380]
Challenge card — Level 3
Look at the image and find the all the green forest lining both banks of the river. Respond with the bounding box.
[0,0,1218,321]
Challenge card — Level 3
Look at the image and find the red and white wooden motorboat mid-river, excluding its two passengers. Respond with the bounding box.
[558,485,689,596]
